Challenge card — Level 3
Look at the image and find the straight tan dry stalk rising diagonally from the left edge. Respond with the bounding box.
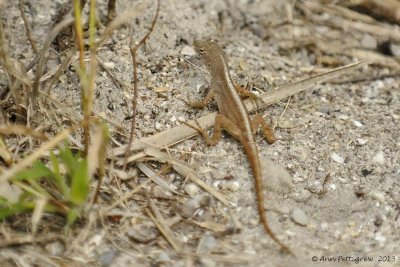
[0,129,71,184]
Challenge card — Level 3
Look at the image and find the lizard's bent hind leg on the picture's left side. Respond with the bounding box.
[185,114,242,146]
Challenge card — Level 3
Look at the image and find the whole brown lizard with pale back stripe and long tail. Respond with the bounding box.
[188,40,293,255]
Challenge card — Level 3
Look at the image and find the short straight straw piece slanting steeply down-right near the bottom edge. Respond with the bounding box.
[145,200,183,252]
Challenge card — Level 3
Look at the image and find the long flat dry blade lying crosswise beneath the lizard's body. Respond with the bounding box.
[114,61,368,157]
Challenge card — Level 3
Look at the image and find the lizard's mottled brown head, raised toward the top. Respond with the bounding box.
[193,40,225,73]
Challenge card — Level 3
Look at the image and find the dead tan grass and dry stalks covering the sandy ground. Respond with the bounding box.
[0,0,400,266]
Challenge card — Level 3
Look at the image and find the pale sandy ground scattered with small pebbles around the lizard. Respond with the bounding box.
[0,0,400,266]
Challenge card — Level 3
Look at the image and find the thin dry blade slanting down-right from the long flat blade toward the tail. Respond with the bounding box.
[145,148,235,206]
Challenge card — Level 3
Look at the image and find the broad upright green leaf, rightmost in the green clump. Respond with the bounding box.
[70,159,89,205]
